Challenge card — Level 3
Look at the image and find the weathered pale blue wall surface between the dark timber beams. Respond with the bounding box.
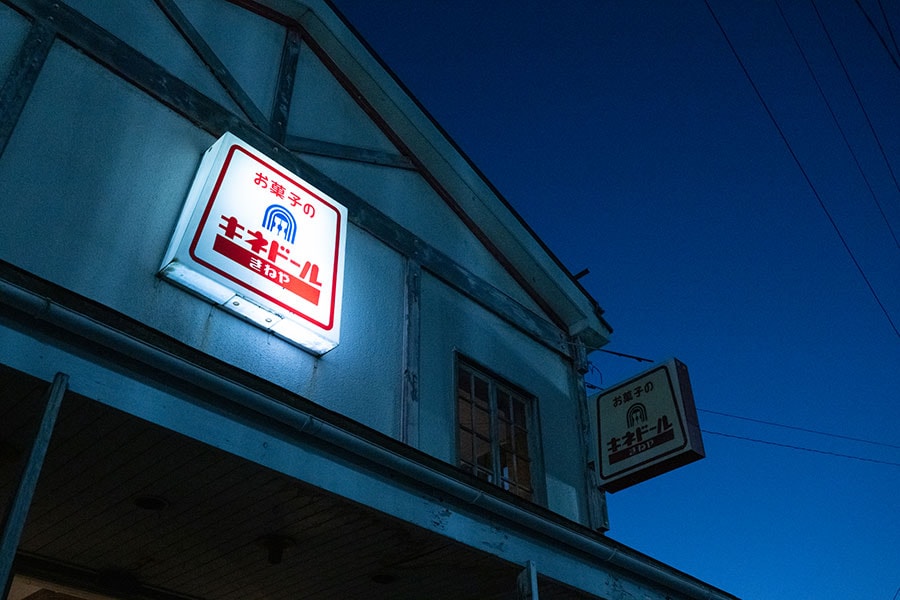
[0,0,587,522]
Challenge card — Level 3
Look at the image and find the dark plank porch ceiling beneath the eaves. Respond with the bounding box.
[0,367,592,600]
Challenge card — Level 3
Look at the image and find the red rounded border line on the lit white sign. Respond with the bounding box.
[188,144,341,331]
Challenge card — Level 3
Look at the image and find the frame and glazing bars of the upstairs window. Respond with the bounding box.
[453,353,545,504]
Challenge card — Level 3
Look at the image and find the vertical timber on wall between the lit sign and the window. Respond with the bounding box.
[400,259,422,446]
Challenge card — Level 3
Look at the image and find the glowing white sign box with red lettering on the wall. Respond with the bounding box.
[159,133,347,355]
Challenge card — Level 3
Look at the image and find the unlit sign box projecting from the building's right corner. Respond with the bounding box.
[596,359,705,492]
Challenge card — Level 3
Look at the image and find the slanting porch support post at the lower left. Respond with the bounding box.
[0,373,69,600]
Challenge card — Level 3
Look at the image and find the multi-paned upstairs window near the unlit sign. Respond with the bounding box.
[456,360,534,500]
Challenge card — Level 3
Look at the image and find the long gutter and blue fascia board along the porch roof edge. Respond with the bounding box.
[0,270,734,600]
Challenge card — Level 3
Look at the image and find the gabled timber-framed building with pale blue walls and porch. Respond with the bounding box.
[0,0,731,600]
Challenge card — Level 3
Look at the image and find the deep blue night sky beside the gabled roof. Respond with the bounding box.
[334,0,900,600]
